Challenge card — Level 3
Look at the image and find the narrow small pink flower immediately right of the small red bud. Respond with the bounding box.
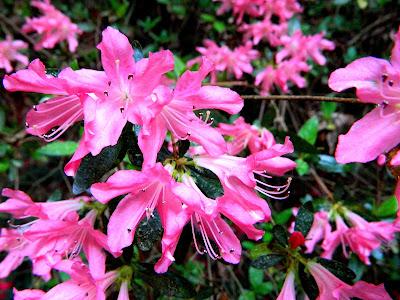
[305,211,331,253]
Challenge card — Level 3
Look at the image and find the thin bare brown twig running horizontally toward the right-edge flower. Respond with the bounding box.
[241,95,364,105]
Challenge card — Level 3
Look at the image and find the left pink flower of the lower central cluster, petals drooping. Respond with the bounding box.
[91,163,187,272]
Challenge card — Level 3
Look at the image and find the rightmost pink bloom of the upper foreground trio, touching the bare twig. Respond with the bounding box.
[139,59,243,165]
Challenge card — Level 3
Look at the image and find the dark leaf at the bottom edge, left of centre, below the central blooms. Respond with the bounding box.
[136,265,196,298]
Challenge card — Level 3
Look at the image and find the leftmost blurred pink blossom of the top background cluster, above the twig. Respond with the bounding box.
[188,40,259,82]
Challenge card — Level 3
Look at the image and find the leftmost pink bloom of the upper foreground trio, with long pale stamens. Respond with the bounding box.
[3,59,104,142]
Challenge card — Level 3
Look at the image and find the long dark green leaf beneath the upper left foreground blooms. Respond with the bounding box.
[72,125,136,194]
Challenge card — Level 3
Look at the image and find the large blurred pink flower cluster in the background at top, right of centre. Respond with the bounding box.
[188,0,335,95]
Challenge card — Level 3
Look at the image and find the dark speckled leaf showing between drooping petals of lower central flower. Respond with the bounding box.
[135,211,163,251]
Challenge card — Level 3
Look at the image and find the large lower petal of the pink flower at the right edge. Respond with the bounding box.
[335,106,400,163]
